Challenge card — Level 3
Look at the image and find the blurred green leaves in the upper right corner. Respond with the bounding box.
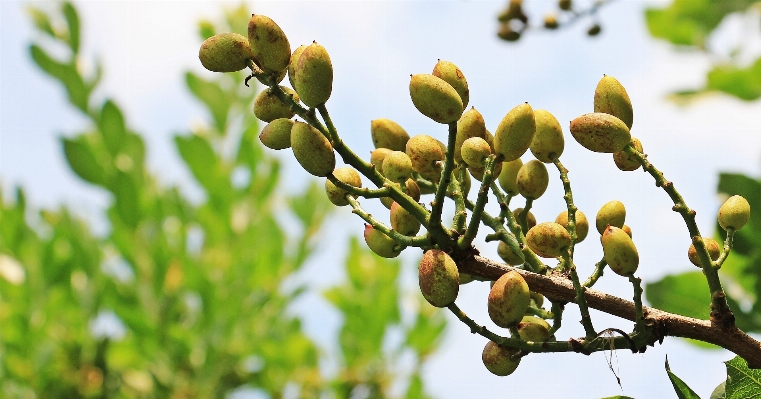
[645,0,761,102]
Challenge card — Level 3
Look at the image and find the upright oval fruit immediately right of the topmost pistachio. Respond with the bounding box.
[293,42,333,108]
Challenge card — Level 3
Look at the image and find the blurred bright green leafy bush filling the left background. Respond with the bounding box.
[0,2,445,398]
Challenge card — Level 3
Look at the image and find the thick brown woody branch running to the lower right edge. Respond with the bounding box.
[457,256,761,369]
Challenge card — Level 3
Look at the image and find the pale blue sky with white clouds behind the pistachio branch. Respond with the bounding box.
[0,0,761,398]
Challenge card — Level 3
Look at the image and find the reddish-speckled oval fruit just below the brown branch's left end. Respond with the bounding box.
[418,249,460,308]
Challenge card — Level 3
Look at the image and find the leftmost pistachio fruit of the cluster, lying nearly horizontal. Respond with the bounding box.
[198,33,254,72]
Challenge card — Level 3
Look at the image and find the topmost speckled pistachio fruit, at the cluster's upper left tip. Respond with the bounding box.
[248,14,291,73]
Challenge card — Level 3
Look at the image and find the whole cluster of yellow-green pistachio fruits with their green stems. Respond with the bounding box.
[199,14,750,375]
